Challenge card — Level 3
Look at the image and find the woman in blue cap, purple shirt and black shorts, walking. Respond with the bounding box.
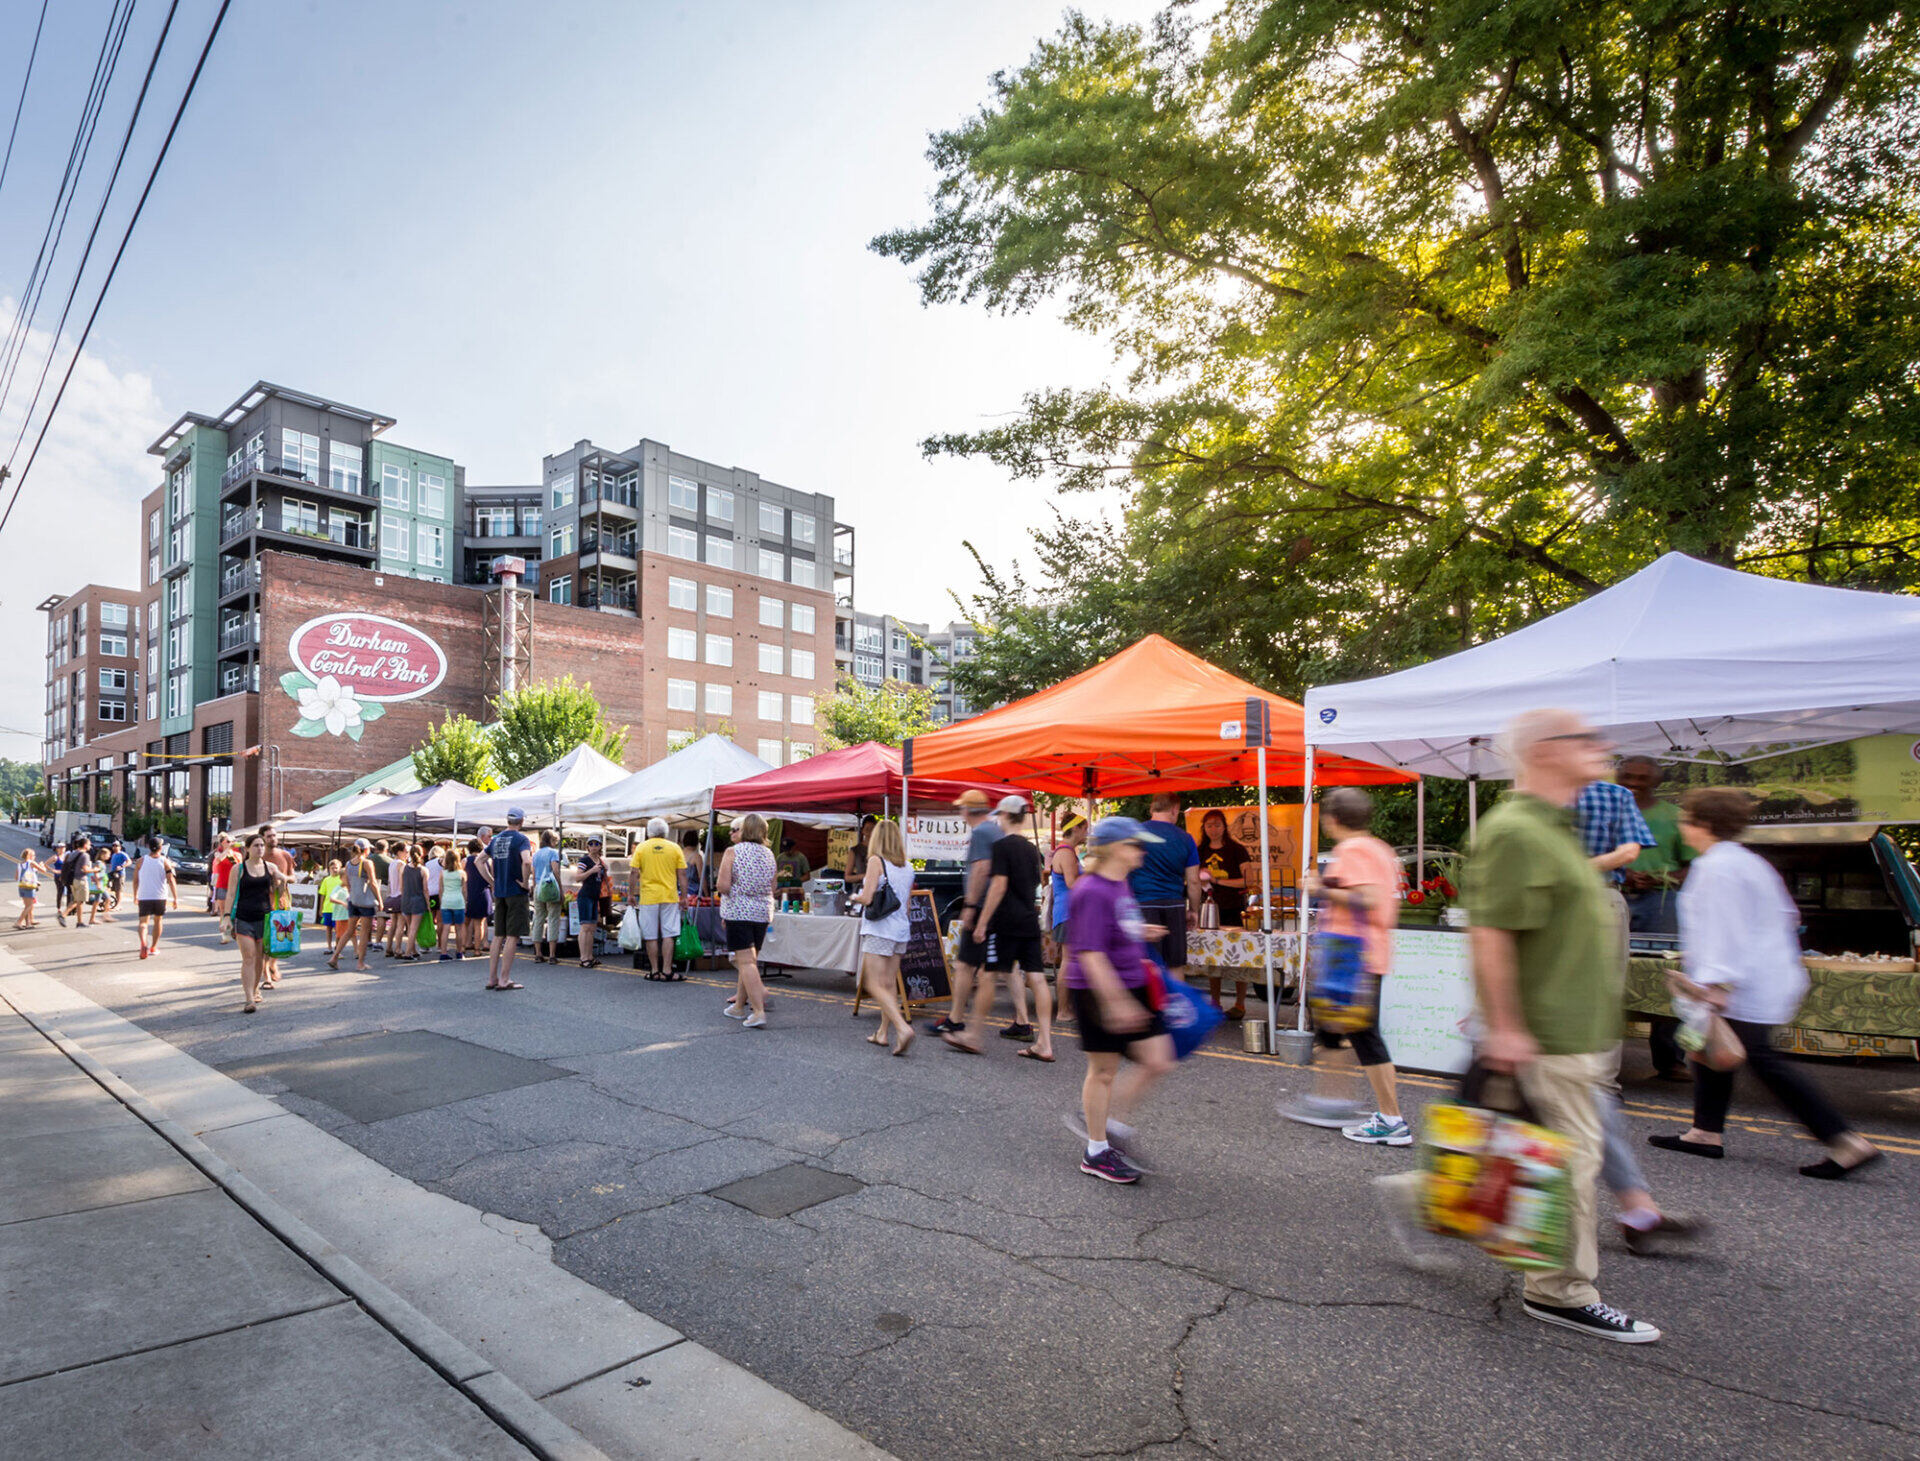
[1060,816,1173,1183]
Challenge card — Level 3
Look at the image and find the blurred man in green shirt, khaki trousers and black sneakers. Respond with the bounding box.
[1465,710,1661,1344]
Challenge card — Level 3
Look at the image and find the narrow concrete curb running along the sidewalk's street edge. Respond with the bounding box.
[0,993,609,1461]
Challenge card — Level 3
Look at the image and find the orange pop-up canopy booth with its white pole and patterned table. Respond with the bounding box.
[904,634,1413,1037]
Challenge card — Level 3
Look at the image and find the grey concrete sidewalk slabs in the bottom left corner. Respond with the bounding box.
[0,1008,549,1461]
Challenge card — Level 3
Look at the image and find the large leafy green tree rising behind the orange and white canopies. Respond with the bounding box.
[874,0,1920,701]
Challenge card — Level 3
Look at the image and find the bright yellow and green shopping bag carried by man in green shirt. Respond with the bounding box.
[1421,1062,1571,1269]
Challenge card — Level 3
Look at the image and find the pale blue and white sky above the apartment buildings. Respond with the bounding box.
[0,0,1154,758]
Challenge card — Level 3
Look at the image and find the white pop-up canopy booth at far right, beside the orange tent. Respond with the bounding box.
[1306,553,1920,1069]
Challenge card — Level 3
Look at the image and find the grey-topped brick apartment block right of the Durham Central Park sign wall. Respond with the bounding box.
[541,440,854,766]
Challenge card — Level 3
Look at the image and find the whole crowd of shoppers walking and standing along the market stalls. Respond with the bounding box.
[15,710,1884,1342]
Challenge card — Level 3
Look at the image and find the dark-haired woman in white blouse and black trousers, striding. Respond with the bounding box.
[1647,787,1882,1181]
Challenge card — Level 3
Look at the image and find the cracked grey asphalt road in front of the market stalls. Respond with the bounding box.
[0,829,1920,1459]
